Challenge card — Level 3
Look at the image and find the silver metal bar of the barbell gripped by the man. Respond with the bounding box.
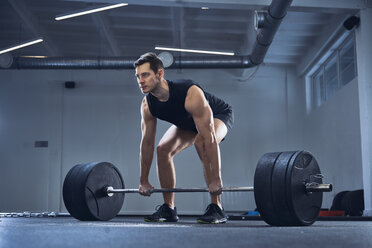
[103,183,332,197]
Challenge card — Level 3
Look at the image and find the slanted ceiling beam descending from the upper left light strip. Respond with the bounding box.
[92,13,120,56]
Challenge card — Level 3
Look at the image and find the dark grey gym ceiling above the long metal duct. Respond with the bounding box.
[0,0,367,67]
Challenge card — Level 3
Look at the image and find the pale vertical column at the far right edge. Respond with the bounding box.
[356,8,372,216]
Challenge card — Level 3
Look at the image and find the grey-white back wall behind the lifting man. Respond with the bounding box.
[0,65,304,213]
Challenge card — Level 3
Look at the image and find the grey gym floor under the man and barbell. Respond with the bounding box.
[0,216,372,248]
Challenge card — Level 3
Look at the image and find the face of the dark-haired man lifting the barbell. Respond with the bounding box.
[136,63,161,94]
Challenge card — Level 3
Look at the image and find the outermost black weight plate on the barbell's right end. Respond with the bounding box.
[286,151,323,226]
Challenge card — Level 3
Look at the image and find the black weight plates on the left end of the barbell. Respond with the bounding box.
[63,162,124,220]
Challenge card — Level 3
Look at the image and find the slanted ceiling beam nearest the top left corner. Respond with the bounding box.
[8,0,58,56]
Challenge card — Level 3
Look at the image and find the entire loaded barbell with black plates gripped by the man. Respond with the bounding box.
[63,151,332,226]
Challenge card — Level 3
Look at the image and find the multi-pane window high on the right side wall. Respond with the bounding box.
[311,33,356,108]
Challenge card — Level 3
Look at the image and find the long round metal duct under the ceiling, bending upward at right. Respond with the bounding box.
[6,0,293,69]
